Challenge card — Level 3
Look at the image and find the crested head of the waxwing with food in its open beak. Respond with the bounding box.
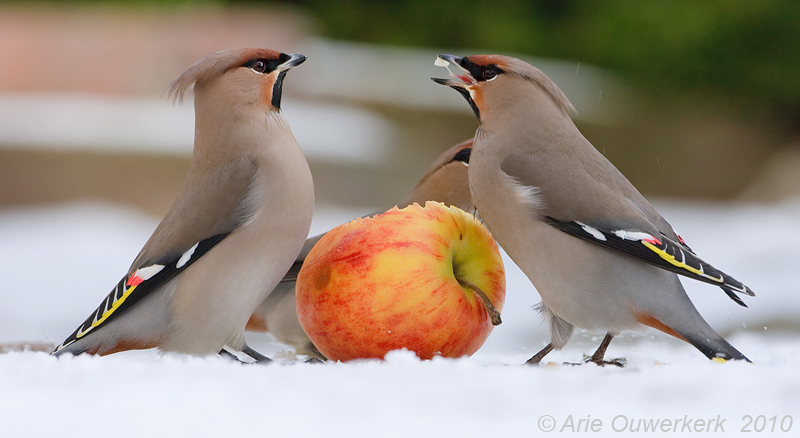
[431,55,575,119]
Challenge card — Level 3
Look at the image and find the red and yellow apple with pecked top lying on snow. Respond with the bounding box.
[297,201,506,361]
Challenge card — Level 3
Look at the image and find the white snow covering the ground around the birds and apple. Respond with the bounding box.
[0,202,800,437]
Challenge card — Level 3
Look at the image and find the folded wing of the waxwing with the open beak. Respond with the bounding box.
[501,150,754,307]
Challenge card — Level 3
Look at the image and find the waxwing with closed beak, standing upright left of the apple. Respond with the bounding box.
[52,48,314,362]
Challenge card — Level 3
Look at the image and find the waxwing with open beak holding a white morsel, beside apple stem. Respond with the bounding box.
[431,54,755,365]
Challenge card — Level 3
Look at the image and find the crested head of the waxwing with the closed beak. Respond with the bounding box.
[169,49,306,111]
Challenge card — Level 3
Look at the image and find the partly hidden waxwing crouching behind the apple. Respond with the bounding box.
[247,140,475,359]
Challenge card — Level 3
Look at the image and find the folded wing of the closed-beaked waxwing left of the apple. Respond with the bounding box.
[54,159,256,353]
